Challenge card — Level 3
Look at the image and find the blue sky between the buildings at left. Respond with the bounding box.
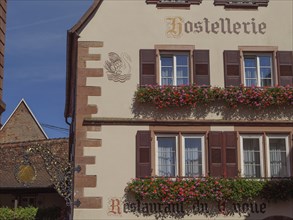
[2,0,92,138]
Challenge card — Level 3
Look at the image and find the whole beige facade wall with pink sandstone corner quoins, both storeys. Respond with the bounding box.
[74,0,293,219]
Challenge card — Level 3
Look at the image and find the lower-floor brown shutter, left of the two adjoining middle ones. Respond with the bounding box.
[209,132,224,177]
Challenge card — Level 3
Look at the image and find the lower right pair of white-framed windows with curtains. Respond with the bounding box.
[240,135,290,178]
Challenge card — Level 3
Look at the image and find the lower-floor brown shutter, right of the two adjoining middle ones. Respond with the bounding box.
[223,132,238,177]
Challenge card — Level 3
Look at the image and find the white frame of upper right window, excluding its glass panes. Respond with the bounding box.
[241,52,276,87]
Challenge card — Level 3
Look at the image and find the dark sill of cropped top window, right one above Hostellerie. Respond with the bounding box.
[214,0,269,9]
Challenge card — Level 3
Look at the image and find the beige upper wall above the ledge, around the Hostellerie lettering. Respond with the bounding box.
[79,0,293,119]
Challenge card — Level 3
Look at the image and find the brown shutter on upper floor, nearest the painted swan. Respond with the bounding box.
[139,49,157,86]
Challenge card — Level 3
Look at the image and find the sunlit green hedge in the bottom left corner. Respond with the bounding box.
[0,207,38,220]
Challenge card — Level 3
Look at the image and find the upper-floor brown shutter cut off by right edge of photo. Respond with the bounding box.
[277,51,293,86]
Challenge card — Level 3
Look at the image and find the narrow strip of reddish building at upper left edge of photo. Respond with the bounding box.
[0,0,7,124]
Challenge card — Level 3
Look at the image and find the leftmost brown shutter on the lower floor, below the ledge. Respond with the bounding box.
[136,131,152,178]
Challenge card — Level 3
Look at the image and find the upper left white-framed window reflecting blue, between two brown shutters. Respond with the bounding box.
[160,53,190,86]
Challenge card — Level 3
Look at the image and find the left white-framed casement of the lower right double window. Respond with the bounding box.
[241,135,264,178]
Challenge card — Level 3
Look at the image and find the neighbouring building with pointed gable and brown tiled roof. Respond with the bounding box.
[0,100,68,217]
